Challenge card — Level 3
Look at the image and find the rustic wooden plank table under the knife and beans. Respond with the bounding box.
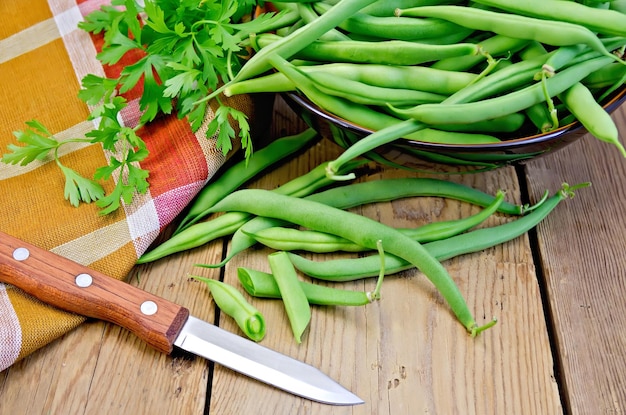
[0,96,626,415]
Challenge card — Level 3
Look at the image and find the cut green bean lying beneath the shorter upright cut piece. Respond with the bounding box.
[237,267,374,306]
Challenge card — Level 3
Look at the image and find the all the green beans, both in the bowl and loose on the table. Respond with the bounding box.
[138,0,608,343]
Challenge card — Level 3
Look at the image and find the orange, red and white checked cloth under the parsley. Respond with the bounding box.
[0,0,266,371]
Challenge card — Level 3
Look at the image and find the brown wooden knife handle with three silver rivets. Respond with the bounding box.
[0,232,189,354]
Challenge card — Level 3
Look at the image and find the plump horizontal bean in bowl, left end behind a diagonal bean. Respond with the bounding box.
[252,33,478,65]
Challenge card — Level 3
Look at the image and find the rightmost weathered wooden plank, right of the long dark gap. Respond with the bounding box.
[526,107,626,415]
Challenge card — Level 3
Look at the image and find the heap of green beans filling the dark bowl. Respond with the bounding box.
[223,0,626,180]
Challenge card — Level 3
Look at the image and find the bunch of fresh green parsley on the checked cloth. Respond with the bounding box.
[2,0,281,214]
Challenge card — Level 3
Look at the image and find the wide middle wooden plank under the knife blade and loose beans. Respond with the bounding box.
[205,101,562,415]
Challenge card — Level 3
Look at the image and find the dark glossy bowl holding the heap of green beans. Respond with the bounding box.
[283,86,626,170]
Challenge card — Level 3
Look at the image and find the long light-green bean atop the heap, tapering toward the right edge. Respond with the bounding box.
[396,6,619,60]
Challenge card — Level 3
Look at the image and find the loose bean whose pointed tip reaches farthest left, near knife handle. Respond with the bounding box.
[137,161,363,264]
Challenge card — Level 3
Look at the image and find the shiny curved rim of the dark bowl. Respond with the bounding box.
[284,85,626,151]
